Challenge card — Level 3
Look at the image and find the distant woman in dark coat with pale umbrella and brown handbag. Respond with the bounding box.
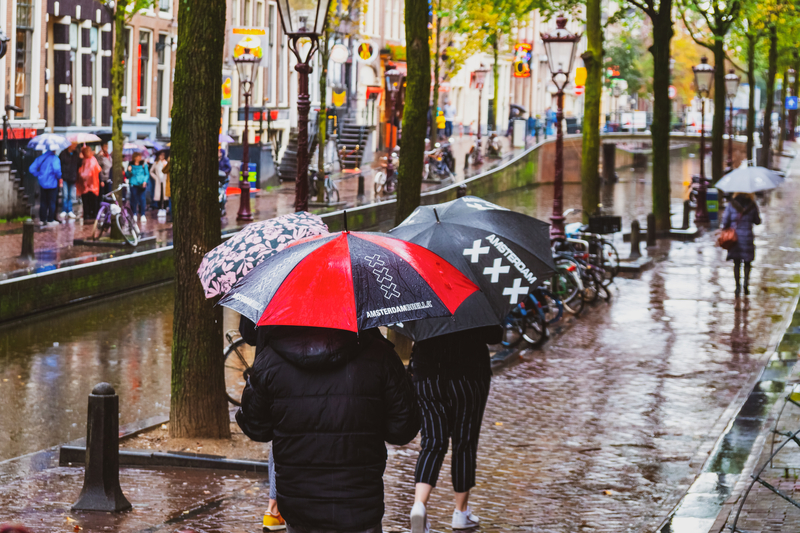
[717,162,783,298]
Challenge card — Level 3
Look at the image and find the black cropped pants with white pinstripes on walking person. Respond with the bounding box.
[414,376,491,492]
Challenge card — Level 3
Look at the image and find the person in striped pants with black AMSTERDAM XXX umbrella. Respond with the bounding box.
[390,196,555,533]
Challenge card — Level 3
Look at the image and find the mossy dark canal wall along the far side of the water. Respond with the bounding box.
[0,134,743,323]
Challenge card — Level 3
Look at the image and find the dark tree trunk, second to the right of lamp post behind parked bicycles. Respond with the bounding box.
[650,10,673,231]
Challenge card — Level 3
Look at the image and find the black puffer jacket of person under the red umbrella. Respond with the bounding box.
[236,327,419,531]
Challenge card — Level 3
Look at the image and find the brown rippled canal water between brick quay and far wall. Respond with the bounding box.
[0,143,708,460]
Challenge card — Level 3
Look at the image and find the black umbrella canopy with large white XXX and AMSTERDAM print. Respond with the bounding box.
[389,196,555,341]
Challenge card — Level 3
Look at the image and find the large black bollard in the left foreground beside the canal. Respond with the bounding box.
[72,383,131,513]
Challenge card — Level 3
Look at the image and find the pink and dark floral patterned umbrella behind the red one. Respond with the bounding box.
[197,211,328,298]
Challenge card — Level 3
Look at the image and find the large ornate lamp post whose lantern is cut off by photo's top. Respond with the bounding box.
[278,0,330,211]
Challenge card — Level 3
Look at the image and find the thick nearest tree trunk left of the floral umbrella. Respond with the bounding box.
[169,0,231,438]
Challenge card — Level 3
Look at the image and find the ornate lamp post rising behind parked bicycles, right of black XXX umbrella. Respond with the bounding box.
[541,14,581,239]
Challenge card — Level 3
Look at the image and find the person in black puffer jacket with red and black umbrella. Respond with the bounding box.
[220,231,477,533]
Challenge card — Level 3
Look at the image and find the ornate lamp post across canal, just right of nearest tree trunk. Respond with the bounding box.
[233,37,262,222]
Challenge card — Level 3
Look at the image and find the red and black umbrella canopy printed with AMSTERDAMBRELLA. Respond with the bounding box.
[220,231,478,331]
